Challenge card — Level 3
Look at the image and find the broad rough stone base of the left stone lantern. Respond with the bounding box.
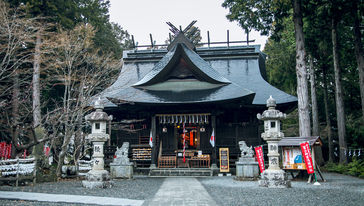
[82,170,112,189]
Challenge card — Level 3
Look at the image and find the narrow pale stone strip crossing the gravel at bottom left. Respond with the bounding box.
[0,191,144,206]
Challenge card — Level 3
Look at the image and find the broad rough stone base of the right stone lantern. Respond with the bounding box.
[259,170,291,188]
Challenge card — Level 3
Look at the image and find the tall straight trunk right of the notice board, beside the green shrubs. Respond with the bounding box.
[331,18,347,163]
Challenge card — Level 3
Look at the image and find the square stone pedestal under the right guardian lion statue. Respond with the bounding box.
[235,158,259,179]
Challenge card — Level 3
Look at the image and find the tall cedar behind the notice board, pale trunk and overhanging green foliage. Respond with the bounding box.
[222,0,311,136]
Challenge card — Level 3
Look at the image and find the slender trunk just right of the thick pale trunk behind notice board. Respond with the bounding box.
[310,56,324,165]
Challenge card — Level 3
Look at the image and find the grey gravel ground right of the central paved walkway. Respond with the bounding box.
[199,173,364,206]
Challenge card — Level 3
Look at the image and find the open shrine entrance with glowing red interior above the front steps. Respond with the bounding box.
[157,113,211,168]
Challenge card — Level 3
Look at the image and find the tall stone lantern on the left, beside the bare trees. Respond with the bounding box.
[82,99,112,188]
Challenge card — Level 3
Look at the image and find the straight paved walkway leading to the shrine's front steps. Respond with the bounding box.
[143,177,217,206]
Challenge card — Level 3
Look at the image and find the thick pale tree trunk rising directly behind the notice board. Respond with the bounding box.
[293,0,311,137]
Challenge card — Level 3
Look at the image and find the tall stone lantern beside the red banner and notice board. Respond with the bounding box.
[257,96,291,188]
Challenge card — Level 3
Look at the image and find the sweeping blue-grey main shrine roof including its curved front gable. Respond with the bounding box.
[95,44,297,111]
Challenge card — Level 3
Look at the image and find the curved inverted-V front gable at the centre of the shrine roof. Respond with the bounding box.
[133,43,231,87]
